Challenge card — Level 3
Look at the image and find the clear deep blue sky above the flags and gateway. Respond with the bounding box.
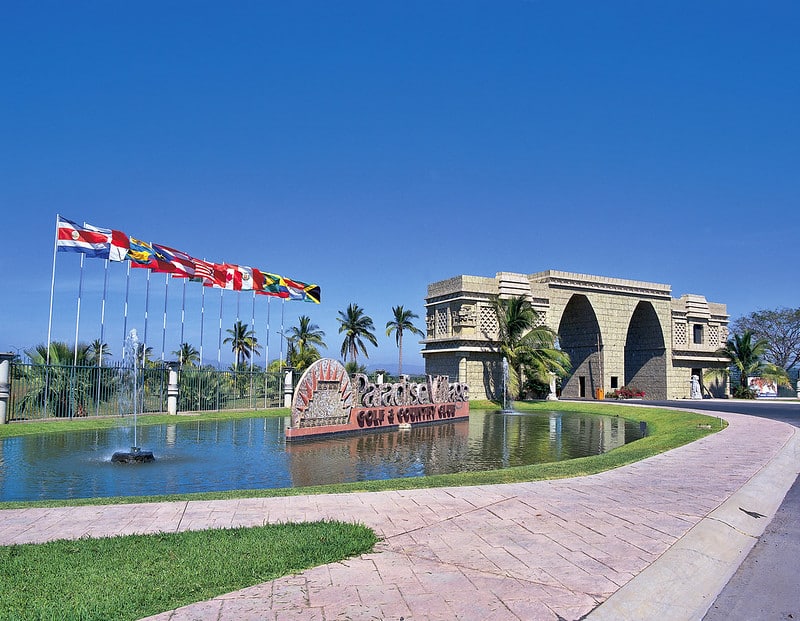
[0,0,800,371]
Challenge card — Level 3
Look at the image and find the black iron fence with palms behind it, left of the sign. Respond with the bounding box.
[7,363,288,422]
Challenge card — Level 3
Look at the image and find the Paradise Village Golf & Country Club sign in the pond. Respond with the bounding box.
[286,358,469,440]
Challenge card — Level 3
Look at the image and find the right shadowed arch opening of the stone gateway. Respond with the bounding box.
[625,301,667,399]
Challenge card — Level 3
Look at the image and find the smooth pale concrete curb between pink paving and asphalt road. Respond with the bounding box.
[585,422,800,621]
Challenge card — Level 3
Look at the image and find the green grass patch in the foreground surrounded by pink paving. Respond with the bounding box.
[0,521,377,621]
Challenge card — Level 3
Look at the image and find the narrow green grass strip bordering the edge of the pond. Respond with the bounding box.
[0,401,724,509]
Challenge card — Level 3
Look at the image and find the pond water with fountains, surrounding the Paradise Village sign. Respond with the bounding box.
[0,410,640,501]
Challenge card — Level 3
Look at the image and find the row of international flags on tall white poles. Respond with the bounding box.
[47,215,321,369]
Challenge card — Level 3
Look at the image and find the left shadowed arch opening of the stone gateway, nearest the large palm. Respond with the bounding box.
[558,294,603,398]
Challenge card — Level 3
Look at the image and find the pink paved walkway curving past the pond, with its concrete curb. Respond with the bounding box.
[0,414,800,621]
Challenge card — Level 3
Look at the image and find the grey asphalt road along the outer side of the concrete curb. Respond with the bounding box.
[657,401,800,621]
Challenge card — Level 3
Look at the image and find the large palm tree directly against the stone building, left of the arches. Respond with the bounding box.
[492,296,570,398]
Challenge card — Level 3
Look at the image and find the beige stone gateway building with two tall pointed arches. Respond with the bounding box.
[422,270,728,399]
